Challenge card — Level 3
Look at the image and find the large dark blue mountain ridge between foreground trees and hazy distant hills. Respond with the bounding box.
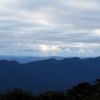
[0,57,100,93]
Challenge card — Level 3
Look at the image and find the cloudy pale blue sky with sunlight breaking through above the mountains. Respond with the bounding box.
[0,0,100,57]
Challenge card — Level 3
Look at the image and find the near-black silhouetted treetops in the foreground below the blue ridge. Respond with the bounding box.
[0,79,100,100]
